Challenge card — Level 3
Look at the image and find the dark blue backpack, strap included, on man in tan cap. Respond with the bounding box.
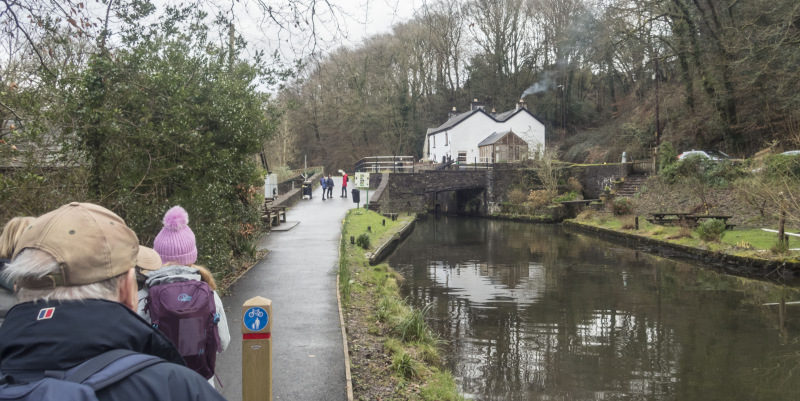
[0,349,165,401]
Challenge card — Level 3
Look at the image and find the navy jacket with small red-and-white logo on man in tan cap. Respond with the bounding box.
[0,299,224,400]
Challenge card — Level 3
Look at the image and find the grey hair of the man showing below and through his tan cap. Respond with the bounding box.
[2,249,125,303]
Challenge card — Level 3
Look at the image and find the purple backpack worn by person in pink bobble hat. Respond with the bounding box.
[146,280,222,379]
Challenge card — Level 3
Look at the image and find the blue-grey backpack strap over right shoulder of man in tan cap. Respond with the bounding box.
[45,349,165,391]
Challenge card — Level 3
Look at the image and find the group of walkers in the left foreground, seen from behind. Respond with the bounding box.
[0,202,230,400]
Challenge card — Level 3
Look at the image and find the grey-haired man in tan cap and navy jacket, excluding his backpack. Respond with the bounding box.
[0,202,224,400]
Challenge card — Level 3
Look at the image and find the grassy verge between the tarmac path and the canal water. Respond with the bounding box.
[339,209,463,400]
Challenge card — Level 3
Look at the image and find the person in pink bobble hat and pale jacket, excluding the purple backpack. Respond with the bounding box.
[137,206,231,386]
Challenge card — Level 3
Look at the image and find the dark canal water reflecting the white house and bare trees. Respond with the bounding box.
[388,216,800,401]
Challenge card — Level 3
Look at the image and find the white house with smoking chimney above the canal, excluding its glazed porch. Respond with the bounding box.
[423,99,544,163]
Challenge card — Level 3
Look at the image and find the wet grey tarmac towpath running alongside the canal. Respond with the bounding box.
[216,177,356,401]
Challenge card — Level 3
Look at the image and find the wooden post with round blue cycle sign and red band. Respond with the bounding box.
[242,297,272,401]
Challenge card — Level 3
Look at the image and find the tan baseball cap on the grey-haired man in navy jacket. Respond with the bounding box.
[14,202,139,289]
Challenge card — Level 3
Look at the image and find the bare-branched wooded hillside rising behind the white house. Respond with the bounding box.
[271,0,800,168]
